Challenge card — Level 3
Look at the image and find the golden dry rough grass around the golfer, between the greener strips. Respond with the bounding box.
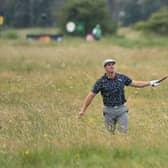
[0,42,168,151]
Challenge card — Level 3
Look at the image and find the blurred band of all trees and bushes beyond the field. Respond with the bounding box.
[0,0,168,35]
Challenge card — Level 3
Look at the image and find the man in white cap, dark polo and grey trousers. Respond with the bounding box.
[79,59,160,134]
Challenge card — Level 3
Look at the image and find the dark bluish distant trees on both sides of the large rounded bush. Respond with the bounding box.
[0,0,168,27]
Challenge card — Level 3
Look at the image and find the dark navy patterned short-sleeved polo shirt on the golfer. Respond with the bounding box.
[91,73,132,107]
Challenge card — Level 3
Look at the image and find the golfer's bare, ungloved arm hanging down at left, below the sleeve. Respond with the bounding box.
[79,92,96,117]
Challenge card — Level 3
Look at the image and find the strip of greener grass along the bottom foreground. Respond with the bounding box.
[0,146,168,168]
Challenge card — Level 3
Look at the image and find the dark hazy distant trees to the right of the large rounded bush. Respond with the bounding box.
[108,0,168,26]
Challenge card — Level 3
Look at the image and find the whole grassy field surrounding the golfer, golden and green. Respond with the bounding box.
[0,29,168,168]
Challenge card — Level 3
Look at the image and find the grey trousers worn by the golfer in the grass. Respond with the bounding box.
[103,105,128,134]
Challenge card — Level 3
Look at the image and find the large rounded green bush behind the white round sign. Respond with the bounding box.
[59,0,117,33]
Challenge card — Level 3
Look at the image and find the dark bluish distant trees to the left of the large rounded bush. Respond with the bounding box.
[0,0,62,27]
